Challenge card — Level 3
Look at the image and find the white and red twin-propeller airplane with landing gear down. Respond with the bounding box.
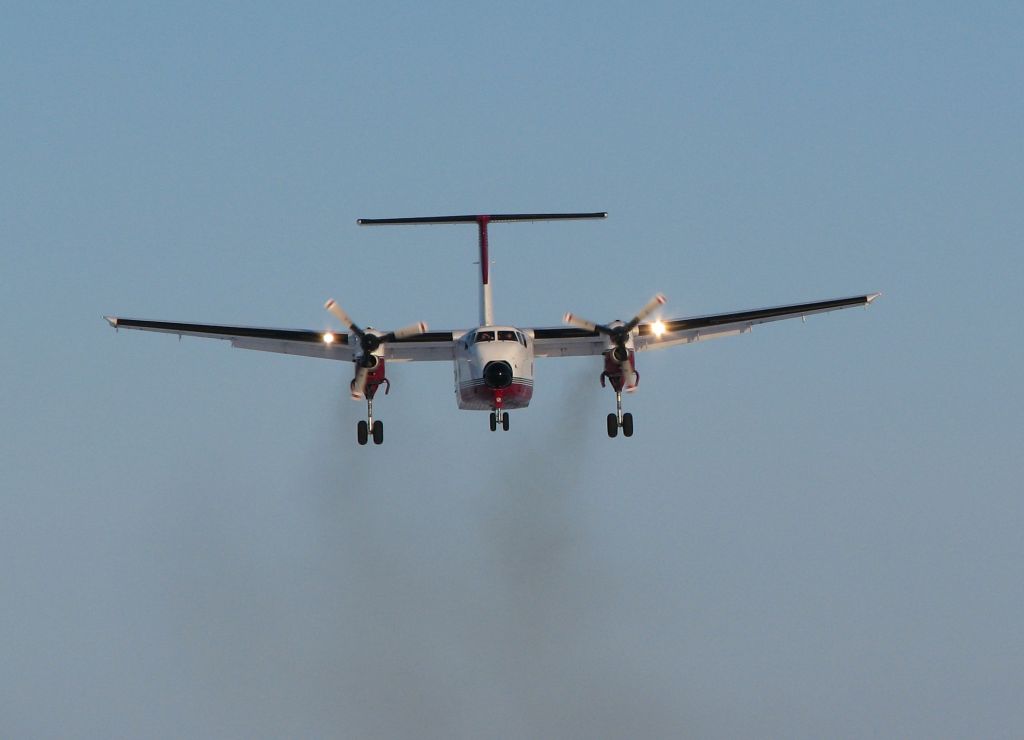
[104,212,881,444]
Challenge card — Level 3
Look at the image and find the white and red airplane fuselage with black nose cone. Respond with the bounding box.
[455,327,534,411]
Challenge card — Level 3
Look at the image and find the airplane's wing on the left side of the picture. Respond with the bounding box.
[103,316,455,361]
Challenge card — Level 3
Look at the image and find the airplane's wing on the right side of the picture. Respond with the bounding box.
[530,293,882,357]
